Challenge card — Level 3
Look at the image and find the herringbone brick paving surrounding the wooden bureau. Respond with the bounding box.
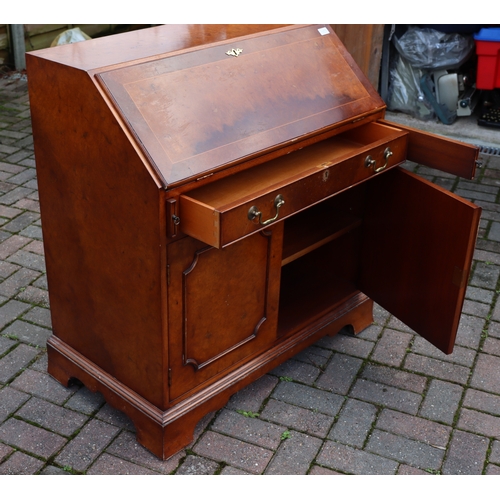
[0,71,500,475]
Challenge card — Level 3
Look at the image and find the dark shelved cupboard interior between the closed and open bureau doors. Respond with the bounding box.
[278,183,366,337]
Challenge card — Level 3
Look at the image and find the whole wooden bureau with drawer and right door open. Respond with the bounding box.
[27,25,480,458]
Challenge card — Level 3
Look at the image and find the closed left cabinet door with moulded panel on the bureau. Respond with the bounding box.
[168,227,283,400]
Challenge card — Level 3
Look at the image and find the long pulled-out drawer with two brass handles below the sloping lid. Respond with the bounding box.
[180,122,408,248]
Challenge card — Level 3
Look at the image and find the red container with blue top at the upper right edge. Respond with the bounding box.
[474,28,500,90]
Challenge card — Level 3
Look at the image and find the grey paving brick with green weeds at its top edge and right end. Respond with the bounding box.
[211,410,287,450]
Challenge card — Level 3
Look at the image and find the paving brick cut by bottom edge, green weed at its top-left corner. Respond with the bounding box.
[265,432,322,475]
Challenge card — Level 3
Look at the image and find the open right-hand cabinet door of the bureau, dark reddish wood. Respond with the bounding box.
[359,168,481,354]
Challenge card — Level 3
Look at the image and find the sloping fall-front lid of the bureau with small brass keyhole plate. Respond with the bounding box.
[97,25,385,186]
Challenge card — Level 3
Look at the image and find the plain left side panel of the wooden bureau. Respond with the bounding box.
[27,55,165,407]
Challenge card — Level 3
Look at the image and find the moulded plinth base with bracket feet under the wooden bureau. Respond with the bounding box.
[47,293,373,460]
